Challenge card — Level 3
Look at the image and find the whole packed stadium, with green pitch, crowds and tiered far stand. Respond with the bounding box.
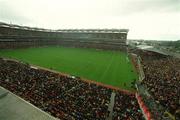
[0,23,180,120]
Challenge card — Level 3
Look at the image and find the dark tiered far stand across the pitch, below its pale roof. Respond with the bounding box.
[0,25,127,50]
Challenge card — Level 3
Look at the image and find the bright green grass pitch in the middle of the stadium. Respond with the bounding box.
[0,47,137,90]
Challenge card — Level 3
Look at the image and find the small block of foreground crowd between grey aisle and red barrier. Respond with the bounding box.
[113,92,145,120]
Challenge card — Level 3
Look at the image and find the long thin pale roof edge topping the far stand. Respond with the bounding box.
[0,22,129,33]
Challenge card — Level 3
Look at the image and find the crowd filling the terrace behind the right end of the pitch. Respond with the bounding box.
[138,51,180,114]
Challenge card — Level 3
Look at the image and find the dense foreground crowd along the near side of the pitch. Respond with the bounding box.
[0,59,143,120]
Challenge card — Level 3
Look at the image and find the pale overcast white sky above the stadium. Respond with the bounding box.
[0,0,180,40]
